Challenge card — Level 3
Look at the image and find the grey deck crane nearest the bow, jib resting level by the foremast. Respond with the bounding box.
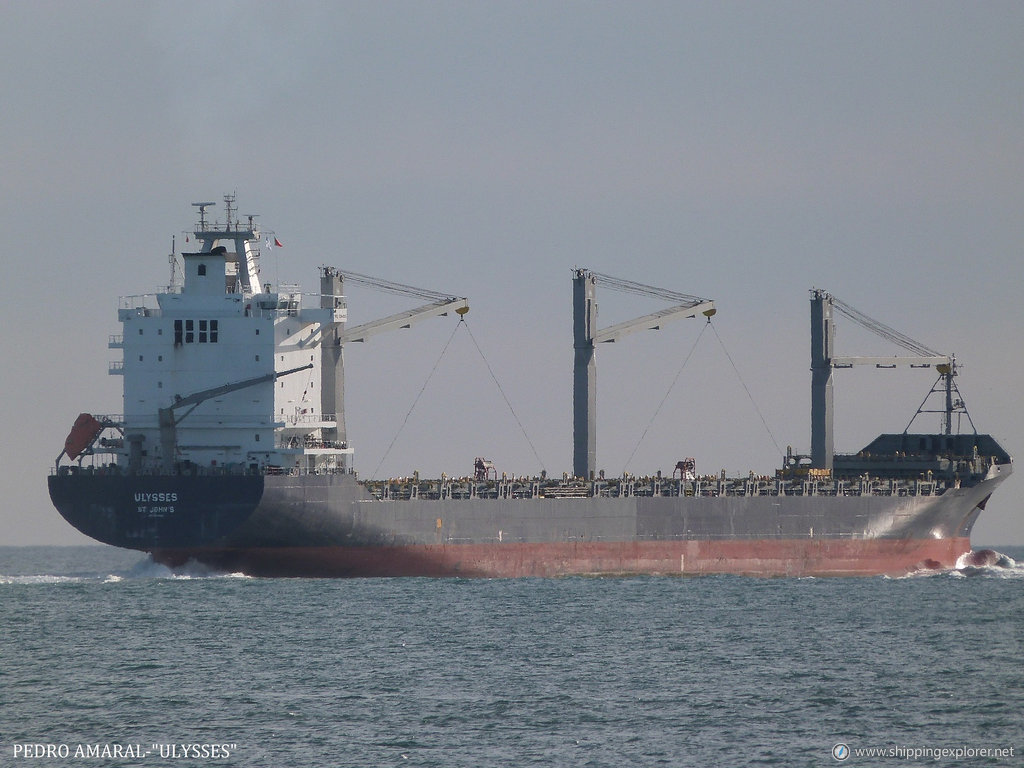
[811,288,970,470]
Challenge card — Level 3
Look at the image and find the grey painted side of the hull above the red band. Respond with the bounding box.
[222,475,1005,548]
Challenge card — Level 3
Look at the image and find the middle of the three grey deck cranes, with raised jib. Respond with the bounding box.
[572,267,716,479]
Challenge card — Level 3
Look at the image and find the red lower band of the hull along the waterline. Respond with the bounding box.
[154,538,971,578]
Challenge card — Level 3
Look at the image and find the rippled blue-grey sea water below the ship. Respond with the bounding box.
[0,547,1024,768]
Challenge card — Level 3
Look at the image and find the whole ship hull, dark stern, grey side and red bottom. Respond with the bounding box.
[50,472,1008,578]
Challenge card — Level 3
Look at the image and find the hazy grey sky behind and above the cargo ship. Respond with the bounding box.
[0,0,1024,545]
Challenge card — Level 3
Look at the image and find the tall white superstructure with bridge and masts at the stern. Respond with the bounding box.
[111,196,352,472]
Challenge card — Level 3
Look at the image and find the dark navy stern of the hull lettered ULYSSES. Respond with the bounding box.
[48,474,264,552]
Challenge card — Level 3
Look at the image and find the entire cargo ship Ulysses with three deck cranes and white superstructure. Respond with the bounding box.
[48,196,1012,578]
